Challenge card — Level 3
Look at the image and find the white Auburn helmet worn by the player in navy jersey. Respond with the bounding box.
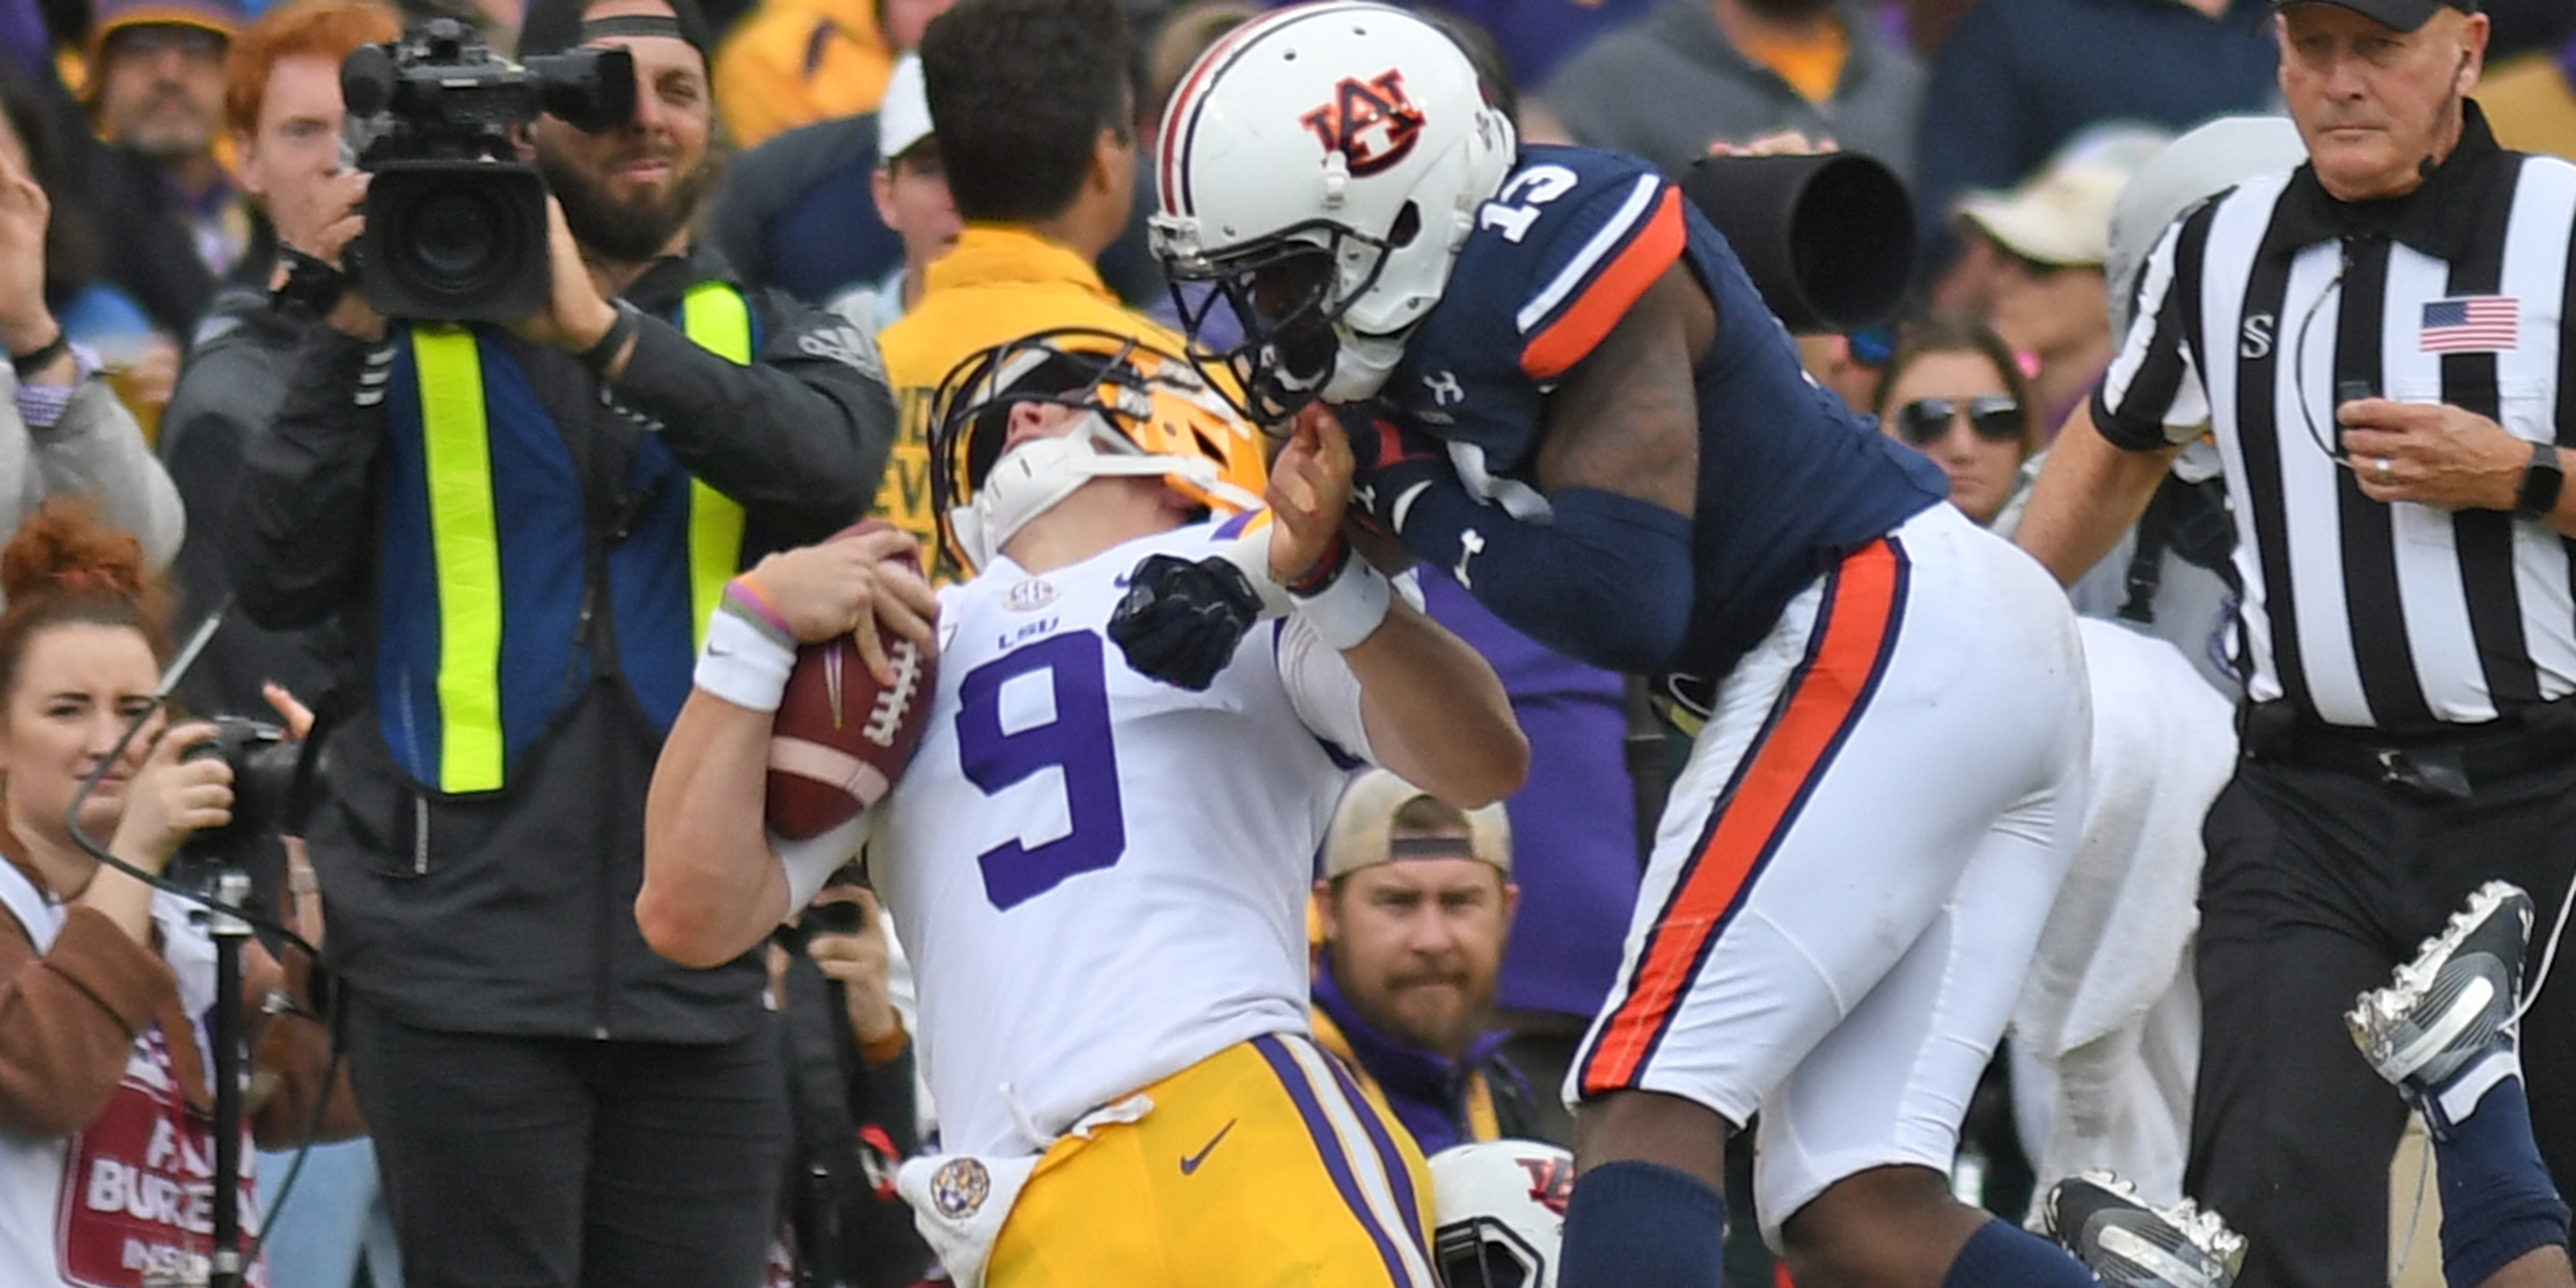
[1152,0,1517,425]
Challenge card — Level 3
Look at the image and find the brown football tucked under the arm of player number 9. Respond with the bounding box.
[767,636,938,840]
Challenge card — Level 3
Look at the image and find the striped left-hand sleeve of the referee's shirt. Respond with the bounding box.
[2092,221,2210,451]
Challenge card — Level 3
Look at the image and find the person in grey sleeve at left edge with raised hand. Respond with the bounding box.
[0,67,186,580]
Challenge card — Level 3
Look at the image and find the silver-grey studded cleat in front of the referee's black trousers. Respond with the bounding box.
[2344,881,2532,1131]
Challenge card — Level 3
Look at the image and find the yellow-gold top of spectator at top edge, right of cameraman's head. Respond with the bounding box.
[716,0,953,147]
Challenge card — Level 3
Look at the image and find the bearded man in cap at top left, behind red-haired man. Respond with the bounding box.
[90,0,258,358]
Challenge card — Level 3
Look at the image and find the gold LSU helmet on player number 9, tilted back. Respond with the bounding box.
[930,327,1268,569]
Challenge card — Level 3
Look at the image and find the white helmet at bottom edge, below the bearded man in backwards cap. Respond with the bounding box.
[1432,1141,1574,1288]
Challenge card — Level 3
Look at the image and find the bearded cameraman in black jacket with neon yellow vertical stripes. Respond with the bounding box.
[224,0,894,1288]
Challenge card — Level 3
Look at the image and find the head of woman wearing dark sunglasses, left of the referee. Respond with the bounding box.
[1870,314,2040,525]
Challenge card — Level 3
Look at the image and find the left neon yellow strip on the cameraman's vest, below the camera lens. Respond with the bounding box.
[412,325,502,791]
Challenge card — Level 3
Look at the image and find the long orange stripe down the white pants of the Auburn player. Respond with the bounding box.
[1584,541,1904,1092]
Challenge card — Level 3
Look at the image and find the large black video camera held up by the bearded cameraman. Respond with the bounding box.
[340,18,636,322]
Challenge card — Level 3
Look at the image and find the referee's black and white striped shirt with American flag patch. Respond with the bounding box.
[2094,103,2576,729]
